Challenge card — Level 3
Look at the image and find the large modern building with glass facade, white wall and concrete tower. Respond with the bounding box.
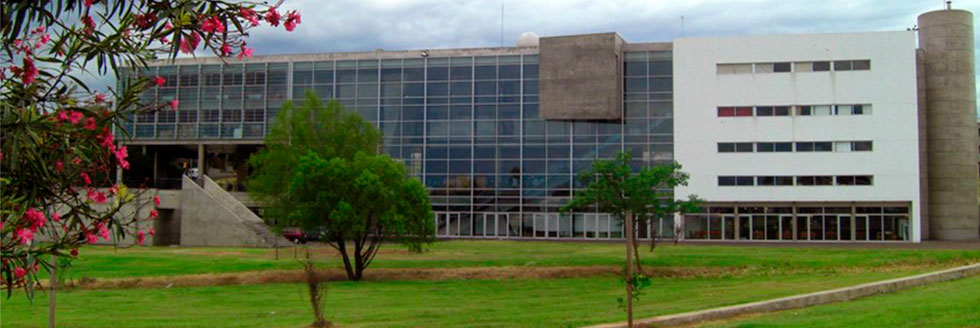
[118,10,980,244]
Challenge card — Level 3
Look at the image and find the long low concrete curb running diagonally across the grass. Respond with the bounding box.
[589,263,980,328]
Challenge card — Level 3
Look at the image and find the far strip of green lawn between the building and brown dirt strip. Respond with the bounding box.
[51,241,980,279]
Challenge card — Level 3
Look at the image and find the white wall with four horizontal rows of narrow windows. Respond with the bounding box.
[674,31,920,241]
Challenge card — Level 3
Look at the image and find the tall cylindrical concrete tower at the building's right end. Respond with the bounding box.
[919,9,980,240]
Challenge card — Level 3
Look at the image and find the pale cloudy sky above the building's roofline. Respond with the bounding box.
[86,0,980,102]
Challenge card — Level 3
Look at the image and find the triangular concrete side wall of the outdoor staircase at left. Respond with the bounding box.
[180,176,267,247]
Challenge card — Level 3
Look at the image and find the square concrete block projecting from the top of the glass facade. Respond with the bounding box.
[539,33,623,120]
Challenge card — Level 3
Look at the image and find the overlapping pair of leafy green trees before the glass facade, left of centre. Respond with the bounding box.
[247,92,435,280]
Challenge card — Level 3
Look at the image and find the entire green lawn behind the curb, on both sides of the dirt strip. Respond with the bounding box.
[0,241,980,327]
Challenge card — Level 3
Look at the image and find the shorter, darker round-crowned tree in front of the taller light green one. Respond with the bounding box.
[282,152,435,281]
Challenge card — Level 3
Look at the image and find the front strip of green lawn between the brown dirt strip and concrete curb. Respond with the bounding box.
[0,273,948,327]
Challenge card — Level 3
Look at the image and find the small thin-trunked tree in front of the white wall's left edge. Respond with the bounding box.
[561,152,699,327]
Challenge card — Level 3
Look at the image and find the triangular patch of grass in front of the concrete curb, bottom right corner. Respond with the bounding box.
[708,277,980,328]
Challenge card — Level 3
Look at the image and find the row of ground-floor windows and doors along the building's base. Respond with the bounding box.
[434,204,912,241]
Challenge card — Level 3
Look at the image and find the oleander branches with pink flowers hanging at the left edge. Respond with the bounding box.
[0,0,300,298]
